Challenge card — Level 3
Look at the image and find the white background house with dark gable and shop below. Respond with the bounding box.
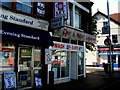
[93,11,120,68]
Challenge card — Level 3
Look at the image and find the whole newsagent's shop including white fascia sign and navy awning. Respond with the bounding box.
[0,9,53,89]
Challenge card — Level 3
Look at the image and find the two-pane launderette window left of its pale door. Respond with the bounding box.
[52,50,69,79]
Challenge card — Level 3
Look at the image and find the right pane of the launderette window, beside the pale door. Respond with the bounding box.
[61,51,69,77]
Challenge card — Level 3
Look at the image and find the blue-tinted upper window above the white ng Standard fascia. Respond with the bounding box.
[16,0,33,13]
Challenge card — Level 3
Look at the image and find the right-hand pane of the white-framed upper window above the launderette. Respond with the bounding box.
[75,8,81,28]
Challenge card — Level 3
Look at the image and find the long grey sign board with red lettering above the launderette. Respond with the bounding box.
[54,27,96,43]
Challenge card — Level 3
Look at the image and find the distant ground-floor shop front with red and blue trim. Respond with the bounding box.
[98,47,120,68]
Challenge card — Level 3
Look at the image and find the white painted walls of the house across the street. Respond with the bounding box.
[86,12,120,65]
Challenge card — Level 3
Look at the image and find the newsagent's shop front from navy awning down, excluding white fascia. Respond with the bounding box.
[0,22,53,89]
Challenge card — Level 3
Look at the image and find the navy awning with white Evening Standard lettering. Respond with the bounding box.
[0,22,53,48]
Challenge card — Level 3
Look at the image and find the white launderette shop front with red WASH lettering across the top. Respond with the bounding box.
[48,41,84,84]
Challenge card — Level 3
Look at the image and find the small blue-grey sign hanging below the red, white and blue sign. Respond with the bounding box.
[51,17,64,29]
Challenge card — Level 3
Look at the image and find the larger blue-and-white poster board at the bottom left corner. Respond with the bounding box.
[4,71,16,90]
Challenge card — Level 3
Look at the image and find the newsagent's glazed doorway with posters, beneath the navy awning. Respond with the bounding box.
[17,45,41,89]
